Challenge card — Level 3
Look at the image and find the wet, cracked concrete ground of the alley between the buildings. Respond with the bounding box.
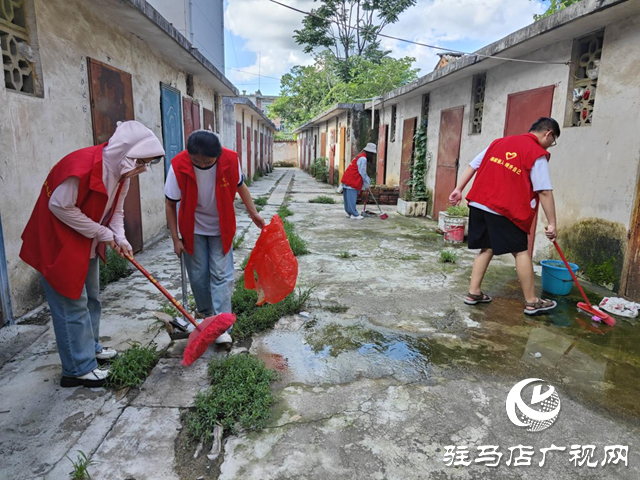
[0,169,640,480]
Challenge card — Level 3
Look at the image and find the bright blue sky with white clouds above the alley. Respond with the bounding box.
[225,0,545,95]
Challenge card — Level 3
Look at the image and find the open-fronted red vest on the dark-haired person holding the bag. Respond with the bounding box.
[171,147,240,255]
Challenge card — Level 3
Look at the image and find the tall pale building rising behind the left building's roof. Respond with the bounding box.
[149,0,224,72]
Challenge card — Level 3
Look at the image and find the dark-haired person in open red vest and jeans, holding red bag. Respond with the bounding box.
[164,130,265,343]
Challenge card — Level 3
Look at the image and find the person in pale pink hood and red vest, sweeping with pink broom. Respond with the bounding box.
[20,121,164,387]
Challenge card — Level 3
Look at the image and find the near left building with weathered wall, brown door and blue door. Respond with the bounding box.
[0,0,238,322]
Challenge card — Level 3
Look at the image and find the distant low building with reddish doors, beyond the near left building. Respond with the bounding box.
[223,97,277,183]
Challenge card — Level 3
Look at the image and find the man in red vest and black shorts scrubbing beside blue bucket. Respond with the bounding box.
[449,117,560,315]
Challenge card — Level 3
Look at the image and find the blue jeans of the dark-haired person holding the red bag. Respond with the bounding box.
[184,234,234,317]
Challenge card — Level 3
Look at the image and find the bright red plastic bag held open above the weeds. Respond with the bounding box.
[244,215,298,305]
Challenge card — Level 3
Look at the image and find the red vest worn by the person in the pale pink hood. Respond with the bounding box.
[20,143,122,299]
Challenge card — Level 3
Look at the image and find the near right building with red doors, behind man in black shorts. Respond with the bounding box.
[368,0,640,299]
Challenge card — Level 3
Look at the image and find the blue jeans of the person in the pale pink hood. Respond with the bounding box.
[42,257,102,377]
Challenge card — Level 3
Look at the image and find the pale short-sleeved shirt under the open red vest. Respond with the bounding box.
[164,162,244,237]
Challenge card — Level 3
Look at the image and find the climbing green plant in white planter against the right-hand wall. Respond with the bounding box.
[397,123,431,217]
